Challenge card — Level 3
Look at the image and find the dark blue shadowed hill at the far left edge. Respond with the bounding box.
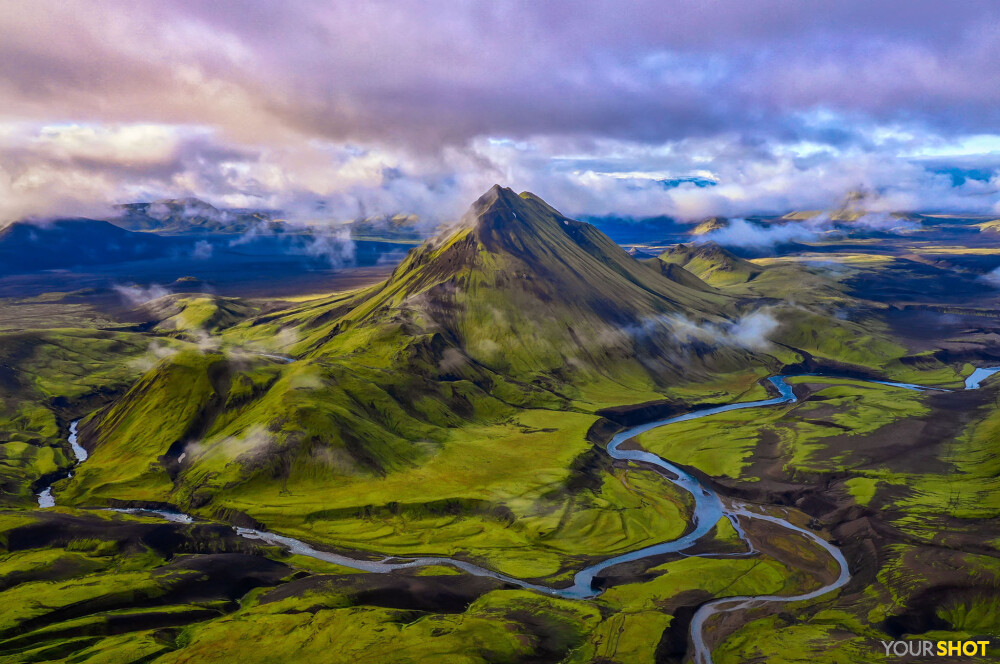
[0,218,173,274]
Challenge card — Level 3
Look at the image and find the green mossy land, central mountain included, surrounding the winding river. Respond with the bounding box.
[0,187,1000,663]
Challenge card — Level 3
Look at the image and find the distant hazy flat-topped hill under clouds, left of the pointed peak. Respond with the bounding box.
[112,198,284,235]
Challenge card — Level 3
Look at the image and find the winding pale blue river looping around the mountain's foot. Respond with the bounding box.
[38,368,1000,664]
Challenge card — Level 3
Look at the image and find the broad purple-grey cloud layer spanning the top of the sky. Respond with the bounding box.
[0,0,1000,145]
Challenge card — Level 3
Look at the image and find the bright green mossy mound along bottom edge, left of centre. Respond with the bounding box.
[160,591,600,664]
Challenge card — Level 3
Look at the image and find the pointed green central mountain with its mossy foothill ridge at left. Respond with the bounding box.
[62,187,766,506]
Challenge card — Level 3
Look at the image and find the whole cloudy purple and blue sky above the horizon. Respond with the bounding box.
[0,0,1000,221]
